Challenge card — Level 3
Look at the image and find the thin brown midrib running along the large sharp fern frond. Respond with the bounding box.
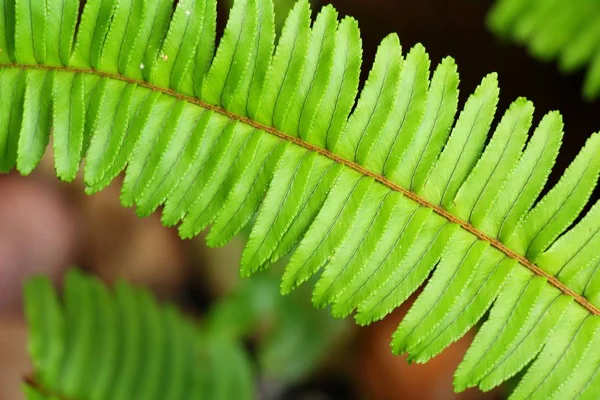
[7,63,600,315]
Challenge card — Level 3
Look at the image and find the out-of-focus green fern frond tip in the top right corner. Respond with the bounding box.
[488,0,600,100]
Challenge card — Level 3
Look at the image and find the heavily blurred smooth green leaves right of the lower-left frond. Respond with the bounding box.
[203,272,350,384]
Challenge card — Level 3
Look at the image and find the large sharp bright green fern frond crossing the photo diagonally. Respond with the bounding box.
[0,0,600,399]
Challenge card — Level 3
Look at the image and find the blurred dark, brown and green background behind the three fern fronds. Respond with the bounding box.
[0,0,600,400]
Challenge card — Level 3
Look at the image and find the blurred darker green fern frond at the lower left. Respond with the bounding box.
[25,270,254,400]
